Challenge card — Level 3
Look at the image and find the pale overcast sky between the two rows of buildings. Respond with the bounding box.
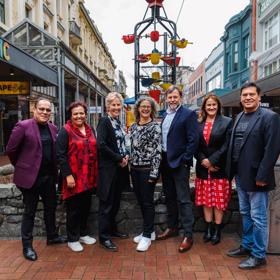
[85,0,250,96]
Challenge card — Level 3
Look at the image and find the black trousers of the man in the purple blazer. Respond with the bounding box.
[19,175,57,247]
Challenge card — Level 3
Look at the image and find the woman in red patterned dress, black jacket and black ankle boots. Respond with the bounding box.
[195,94,232,245]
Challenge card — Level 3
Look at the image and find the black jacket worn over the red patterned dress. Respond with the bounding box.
[195,115,232,179]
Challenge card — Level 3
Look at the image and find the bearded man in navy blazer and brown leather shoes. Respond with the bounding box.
[157,86,198,253]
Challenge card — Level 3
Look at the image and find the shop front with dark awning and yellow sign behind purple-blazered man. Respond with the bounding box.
[0,37,58,154]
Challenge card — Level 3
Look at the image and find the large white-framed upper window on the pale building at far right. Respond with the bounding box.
[264,13,279,50]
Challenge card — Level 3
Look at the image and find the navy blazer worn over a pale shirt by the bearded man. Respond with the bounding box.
[163,106,198,168]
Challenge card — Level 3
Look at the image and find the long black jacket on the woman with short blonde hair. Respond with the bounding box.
[97,117,129,201]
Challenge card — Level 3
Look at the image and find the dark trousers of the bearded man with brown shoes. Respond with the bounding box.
[161,153,194,237]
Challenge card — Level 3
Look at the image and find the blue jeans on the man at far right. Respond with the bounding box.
[235,176,268,258]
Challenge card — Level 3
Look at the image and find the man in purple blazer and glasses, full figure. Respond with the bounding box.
[6,98,66,261]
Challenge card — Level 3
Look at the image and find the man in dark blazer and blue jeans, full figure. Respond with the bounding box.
[227,83,280,269]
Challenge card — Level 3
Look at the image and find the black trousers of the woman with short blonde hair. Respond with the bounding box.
[98,167,123,241]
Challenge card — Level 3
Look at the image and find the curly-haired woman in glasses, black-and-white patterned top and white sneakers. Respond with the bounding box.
[129,97,161,252]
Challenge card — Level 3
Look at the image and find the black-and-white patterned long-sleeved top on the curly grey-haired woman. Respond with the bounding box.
[129,121,162,179]
